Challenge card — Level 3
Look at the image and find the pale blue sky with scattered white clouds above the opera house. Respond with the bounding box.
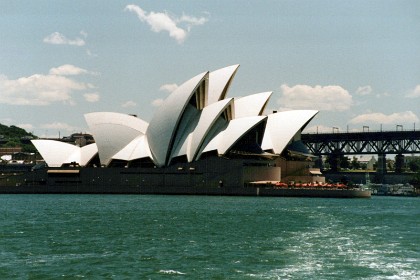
[0,0,420,137]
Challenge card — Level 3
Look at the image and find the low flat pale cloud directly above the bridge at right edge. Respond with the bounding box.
[349,111,419,124]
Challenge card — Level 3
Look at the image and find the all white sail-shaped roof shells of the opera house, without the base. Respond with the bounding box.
[33,65,317,167]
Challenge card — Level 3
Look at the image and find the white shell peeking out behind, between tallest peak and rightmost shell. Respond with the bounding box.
[235,91,273,119]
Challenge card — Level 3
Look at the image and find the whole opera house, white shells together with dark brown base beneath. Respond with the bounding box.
[32,65,317,188]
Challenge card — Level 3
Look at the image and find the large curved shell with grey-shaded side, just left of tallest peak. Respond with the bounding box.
[146,72,208,166]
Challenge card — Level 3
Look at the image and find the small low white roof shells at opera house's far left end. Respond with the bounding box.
[32,139,98,167]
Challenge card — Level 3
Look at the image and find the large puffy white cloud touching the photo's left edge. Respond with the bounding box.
[0,65,94,106]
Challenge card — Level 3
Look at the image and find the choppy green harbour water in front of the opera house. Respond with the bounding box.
[0,195,420,279]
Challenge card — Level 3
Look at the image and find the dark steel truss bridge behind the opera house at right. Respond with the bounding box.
[302,130,420,173]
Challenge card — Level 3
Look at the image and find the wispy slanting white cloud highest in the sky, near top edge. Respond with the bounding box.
[125,5,208,44]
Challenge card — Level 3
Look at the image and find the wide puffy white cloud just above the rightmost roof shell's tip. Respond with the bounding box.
[278,85,353,112]
